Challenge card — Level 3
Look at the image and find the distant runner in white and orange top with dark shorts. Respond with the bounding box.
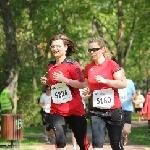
[133,89,145,122]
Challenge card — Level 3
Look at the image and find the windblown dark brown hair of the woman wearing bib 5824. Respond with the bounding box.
[49,34,77,56]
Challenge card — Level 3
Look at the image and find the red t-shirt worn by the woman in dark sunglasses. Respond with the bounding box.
[85,59,121,109]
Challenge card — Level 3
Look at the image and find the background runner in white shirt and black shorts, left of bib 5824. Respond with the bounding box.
[39,85,55,144]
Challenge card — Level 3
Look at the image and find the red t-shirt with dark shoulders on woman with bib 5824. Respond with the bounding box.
[48,58,85,116]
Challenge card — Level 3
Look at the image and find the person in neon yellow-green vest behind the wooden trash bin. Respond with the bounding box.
[0,80,14,114]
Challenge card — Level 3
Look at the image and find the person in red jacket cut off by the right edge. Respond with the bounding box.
[142,88,150,140]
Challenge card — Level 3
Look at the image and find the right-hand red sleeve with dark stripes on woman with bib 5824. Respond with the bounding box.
[70,62,84,82]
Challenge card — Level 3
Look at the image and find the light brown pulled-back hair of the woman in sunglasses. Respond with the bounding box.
[88,37,113,59]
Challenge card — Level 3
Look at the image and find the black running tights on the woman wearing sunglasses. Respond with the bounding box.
[90,108,124,150]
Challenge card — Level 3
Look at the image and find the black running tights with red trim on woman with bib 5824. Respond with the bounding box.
[50,114,89,150]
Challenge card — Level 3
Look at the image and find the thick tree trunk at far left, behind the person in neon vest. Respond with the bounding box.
[0,0,20,113]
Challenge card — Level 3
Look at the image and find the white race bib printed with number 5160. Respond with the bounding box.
[93,89,114,109]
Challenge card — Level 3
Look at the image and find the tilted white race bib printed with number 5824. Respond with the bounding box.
[51,83,72,104]
